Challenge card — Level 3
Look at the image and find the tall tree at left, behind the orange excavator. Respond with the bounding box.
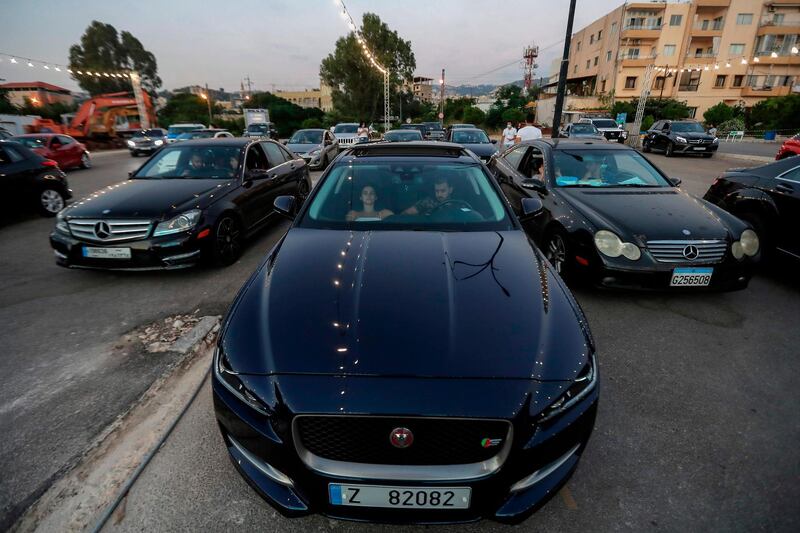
[69,20,161,95]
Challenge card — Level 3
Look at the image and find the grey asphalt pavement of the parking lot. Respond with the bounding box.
[0,148,800,531]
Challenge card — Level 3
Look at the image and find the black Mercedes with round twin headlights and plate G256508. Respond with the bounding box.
[490,139,759,290]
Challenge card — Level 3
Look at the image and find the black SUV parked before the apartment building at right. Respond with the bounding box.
[642,120,719,157]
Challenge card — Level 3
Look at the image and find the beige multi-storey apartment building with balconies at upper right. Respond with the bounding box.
[567,0,800,118]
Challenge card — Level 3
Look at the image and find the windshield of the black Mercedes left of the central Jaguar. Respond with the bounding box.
[133,144,242,179]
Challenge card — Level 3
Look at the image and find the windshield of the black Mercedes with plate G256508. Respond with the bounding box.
[553,150,672,187]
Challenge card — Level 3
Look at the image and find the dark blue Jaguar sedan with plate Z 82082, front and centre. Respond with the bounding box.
[212,142,599,523]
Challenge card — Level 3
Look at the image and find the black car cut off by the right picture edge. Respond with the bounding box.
[704,157,800,259]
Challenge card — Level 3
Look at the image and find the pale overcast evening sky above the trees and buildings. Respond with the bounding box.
[0,0,622,91]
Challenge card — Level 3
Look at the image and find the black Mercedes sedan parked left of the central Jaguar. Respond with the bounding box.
[50,139,311,270]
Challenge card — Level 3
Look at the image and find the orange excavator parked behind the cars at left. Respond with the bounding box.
[26,91,156,145]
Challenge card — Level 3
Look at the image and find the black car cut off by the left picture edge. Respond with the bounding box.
[0,139,72,217]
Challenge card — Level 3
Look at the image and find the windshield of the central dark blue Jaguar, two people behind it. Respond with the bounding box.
[299,158,513,231]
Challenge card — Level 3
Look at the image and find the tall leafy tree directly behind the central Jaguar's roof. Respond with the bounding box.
[319,13,417,122]
